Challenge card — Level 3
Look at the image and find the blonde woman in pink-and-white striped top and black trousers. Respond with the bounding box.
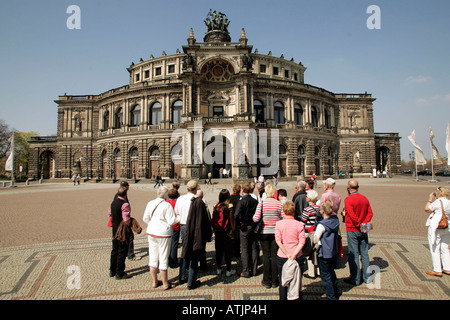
[253,184,284,289]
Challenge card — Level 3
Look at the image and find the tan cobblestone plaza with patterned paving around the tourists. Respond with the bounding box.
[0,178,450,301]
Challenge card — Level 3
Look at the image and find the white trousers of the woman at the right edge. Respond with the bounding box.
[428,228,450,272]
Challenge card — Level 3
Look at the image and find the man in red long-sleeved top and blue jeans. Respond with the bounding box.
[342,179,373,286]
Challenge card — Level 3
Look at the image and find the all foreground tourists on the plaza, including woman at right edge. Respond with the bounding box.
[110,178,450,300]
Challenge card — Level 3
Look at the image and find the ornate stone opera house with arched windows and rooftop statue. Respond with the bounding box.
[29,12,400,180]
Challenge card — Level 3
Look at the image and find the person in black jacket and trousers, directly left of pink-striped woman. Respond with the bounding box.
[234,183,258,278]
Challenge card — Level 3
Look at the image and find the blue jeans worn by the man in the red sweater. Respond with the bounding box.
[347,232,369,285]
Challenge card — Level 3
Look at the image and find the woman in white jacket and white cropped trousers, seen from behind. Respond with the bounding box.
[143,186,180,290]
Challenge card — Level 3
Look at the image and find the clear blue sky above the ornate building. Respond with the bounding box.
[0,0,450,160]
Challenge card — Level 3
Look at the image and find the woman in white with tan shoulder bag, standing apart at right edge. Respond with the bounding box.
[425,187,450,277]
